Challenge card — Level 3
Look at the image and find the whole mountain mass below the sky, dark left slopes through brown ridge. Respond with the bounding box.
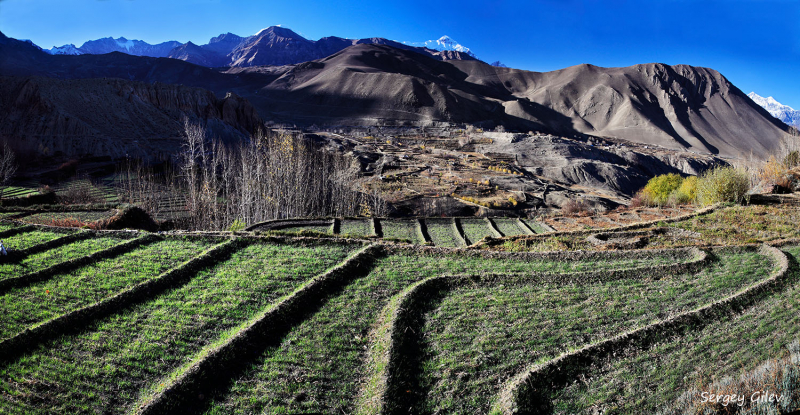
[0,27,789,162]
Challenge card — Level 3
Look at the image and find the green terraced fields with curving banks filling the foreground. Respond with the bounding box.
[0,214,800,414]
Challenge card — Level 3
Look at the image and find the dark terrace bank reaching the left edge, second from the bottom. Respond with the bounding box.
[0,234,163,294]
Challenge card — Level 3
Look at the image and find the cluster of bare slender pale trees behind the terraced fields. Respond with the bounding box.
[123,120,386,230]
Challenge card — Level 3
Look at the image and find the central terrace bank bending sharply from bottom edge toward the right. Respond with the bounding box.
[356,248,712,415]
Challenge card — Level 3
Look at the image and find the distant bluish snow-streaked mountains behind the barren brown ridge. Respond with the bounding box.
[43,26,475,68]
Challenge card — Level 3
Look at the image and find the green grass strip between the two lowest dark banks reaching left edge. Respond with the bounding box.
[0,239,210,339]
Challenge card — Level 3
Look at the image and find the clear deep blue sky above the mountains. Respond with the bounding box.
[0,0,800,109]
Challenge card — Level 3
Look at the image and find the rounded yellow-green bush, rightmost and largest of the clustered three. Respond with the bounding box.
[697,167,750,205]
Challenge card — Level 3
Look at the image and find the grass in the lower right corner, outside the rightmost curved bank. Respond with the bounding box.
[552,247,800,413]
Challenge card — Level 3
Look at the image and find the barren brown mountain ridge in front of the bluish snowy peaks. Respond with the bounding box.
[0,30,787,161]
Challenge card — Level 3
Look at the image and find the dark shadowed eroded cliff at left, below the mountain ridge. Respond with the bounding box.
[0,77,261,159]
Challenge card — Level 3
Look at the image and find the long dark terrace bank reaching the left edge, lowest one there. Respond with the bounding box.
[0,238,242,361]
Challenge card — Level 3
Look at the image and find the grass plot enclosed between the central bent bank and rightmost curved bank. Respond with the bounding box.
[418,249,773,413]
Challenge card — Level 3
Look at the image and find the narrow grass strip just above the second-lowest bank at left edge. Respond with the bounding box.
[0,237,130,280]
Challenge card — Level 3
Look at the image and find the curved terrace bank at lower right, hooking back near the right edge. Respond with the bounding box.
[490,245,791,415]
